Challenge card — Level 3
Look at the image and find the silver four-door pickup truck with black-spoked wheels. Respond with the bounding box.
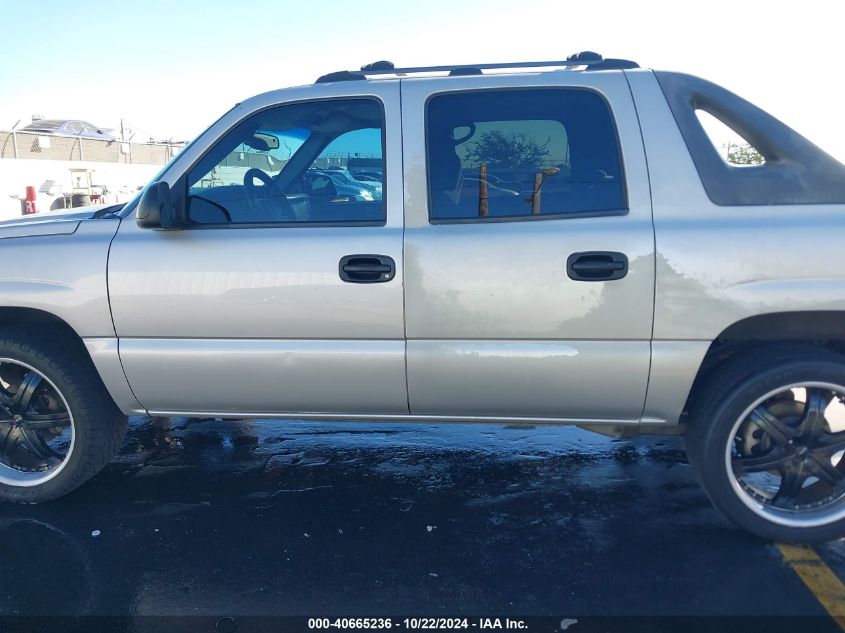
[0,53,845,541]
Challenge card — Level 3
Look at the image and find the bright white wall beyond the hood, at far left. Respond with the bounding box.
[0,159,162,221]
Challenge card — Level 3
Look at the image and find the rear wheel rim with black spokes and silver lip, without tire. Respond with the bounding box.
[725,382,845,527]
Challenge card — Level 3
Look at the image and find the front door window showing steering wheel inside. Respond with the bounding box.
[188,99,385,224]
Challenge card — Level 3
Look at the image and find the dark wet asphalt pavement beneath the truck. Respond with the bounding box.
[0,418,845,631]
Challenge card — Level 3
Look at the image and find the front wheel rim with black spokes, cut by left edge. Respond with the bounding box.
[0,358,76,487]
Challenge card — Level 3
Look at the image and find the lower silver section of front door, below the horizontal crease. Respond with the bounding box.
[120,338,408,415]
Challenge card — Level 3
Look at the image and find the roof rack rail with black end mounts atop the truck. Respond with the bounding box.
[316,51,640,84]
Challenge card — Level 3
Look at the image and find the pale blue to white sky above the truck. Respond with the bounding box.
[0,0,845,159]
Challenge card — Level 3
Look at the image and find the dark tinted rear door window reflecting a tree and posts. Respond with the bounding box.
[427,89,626,220]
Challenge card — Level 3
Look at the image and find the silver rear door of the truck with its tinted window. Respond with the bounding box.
[401,71,655,423]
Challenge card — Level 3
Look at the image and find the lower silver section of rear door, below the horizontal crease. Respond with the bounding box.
[408,340,649,420]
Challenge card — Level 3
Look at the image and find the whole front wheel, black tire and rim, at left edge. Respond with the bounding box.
[0,328,127,503]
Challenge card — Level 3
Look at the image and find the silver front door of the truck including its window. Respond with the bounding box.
[108,81,408,416]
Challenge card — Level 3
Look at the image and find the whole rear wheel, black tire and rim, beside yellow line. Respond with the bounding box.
[687,344,845,543]
